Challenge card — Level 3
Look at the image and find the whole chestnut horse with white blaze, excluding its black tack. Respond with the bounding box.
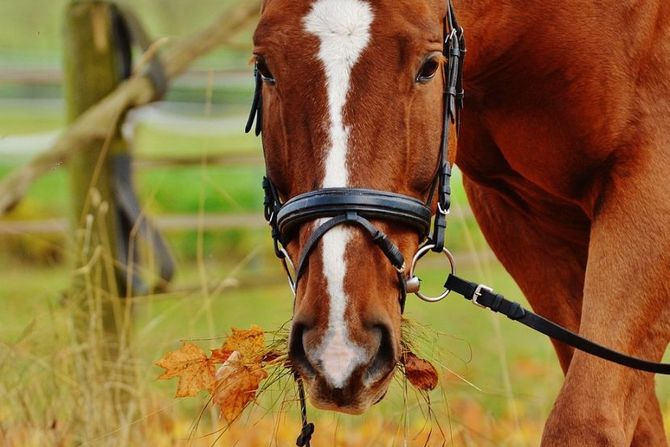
[254,0,670,446]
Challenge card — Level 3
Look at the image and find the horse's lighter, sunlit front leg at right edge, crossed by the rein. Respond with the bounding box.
[543,151,670,446]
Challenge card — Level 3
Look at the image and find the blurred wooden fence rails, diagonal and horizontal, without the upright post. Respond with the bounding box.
[0,1,484,262]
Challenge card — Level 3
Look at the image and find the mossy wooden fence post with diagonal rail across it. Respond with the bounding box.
[0,0,260,418]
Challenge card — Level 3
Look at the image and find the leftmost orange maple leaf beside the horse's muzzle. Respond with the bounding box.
[155,343,215,397]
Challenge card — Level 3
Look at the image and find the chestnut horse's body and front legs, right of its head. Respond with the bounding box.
[457,0,670,446]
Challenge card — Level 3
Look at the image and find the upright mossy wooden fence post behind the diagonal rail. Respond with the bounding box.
[63,0,135,436]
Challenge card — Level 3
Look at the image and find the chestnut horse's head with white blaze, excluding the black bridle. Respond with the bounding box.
[254,0,456,414]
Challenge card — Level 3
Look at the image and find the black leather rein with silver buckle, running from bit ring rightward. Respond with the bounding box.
[444,275,670,375]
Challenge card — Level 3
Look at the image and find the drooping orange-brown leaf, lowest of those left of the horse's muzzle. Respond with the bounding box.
[212,351,268,424]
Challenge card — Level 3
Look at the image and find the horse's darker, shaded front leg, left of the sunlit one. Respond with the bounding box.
[463,176,589,373]
